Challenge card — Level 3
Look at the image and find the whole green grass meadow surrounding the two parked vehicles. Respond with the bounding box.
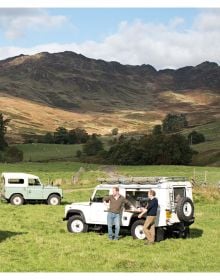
[0,162,220,272]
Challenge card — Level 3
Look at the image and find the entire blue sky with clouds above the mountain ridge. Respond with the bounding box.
[0,2,220,69]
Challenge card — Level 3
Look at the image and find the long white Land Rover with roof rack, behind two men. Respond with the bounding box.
[63,177,194,241]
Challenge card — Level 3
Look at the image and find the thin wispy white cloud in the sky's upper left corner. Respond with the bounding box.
[0,9,67,40]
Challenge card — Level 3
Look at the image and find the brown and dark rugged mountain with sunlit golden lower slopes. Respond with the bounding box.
[0,51,220,142]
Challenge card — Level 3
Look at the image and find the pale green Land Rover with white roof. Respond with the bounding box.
[1,172,63,205]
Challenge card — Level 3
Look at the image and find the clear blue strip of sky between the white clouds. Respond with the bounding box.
[0,8,200,47]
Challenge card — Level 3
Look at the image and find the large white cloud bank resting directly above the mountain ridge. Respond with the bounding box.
[0,10,220,69]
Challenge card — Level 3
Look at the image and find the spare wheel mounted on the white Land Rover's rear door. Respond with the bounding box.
[176,197,194,222]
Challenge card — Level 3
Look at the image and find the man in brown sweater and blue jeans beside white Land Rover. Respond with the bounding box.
[103,187,132,240]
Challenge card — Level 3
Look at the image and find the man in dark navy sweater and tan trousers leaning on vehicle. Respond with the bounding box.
[138,190,158,245]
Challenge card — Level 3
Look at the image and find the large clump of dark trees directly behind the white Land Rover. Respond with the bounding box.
[80,114,205,165]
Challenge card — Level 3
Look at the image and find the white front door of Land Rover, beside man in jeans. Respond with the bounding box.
[90,190,109,225]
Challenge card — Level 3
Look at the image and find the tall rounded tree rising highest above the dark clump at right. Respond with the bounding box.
[162,114,188,133]
